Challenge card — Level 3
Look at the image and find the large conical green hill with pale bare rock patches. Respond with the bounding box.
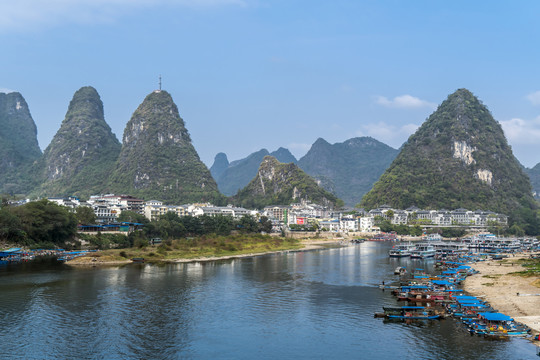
[362,89,535,225]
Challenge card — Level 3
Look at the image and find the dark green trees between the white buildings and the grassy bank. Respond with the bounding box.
[0,199,272,248]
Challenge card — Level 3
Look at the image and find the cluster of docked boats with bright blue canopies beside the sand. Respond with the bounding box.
[375,256,530,338]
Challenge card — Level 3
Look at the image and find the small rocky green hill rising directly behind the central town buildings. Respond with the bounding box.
[233,156,339,208]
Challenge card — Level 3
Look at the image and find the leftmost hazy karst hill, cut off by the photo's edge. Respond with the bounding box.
[0,92,41,193]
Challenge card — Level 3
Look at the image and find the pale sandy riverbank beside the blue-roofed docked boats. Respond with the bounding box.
[463,254,540,334]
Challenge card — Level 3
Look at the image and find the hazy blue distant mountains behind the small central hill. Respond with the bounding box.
[210,137,399,206]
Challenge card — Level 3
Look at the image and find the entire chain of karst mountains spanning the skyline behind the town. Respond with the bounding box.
[0,86,540,231]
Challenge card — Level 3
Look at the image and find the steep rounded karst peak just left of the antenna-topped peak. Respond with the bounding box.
[35,86,120,196]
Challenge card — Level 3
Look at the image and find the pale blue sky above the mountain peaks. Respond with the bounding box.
[0,0,540,167]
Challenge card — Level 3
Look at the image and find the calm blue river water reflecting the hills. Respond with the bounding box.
[0,242,537,360]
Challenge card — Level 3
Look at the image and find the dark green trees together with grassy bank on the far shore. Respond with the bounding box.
[0,200,292,259]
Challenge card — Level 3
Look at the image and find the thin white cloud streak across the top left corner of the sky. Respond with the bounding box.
[0,0,246,32]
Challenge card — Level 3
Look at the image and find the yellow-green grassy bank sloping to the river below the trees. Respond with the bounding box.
[69,235,302,262]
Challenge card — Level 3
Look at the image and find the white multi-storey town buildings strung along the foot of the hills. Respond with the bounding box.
[16,194,508,234]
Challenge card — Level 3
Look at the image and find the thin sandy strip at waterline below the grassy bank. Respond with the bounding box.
[66,239,344,266]
